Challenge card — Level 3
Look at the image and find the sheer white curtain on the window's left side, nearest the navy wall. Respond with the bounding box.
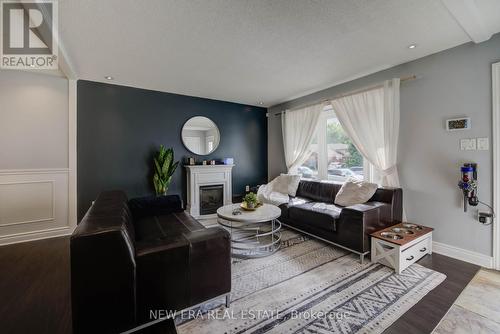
[281,103,325,174]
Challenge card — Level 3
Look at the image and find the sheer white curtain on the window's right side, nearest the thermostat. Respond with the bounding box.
[331,79,400,187]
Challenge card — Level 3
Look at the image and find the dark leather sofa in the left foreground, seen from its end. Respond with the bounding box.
[71,191,231,333]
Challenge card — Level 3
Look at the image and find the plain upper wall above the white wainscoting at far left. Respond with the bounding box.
[0,71,68,169]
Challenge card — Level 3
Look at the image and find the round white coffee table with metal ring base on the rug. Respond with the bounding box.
[217,203,281,258]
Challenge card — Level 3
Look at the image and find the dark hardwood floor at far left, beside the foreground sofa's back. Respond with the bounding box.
[0,237,71,334]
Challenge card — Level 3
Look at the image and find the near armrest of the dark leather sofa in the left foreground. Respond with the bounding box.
[136,227,231,322]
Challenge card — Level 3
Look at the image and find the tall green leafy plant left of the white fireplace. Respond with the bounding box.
[153,145,179,196]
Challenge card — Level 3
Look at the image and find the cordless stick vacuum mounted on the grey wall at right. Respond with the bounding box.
[458,162,495,225]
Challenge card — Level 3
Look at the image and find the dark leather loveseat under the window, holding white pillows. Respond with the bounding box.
[280,180,403,260]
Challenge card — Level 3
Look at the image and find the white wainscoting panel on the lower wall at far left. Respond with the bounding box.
[0,169,72,245]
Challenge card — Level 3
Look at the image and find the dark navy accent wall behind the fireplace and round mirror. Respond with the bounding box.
[77,80,267,220]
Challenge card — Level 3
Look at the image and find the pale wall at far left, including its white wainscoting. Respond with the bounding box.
[0,71,70,244]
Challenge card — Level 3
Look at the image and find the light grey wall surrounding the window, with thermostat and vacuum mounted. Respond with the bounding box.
[268,34,500,264]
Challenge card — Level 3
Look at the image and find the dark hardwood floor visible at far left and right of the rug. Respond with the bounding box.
[0,237,479,334]
